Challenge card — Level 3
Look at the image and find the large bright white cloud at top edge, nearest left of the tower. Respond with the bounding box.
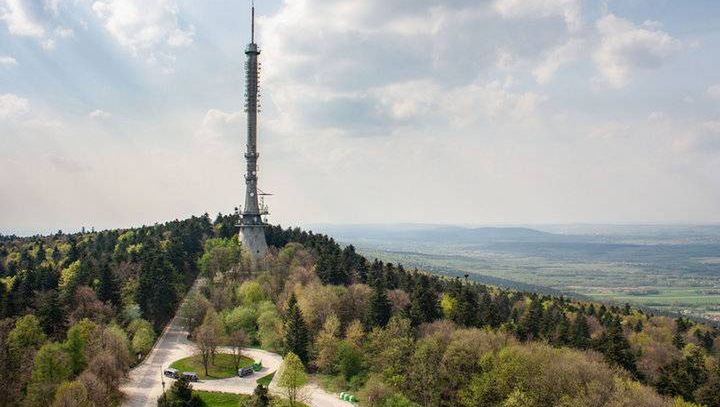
[92,0,195,61]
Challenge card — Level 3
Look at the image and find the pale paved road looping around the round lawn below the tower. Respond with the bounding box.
[120,290,351,407]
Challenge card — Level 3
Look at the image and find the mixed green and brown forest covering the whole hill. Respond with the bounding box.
[0,215,720,407]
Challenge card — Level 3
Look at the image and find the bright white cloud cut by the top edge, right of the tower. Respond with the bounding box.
[494,0,582,31]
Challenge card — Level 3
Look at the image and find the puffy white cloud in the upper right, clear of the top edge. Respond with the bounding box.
[594,14,683,88]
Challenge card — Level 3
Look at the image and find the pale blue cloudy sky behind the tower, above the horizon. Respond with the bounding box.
[0,0,720,233]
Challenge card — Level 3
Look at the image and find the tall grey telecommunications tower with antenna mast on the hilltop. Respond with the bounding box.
[238,5,267,266]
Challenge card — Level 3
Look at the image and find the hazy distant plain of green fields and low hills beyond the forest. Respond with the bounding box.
[321,226,720,322]
